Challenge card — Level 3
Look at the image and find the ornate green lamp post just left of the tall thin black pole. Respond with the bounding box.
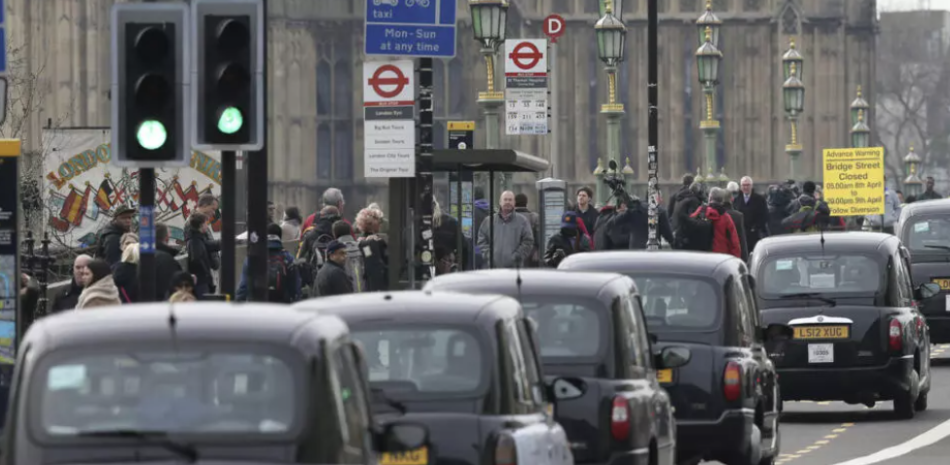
[594,0,627,207]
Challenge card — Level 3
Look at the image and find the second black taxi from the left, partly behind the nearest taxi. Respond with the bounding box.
[294,291,579,465]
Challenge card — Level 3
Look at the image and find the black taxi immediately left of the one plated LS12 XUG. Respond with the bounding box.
[558,251,781,465]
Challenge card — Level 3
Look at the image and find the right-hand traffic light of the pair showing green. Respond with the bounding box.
[192,0,265,151]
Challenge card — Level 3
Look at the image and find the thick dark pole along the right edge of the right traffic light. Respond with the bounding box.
[247,0,269,302]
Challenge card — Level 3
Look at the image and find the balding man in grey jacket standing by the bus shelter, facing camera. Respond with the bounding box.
[478,191,534,268]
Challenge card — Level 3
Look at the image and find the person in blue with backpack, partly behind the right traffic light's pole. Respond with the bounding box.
[235,223,300,304]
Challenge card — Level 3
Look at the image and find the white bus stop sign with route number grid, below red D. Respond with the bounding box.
[505,39,548,135]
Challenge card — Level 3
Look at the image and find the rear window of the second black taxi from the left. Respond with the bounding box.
[352,325,488,397]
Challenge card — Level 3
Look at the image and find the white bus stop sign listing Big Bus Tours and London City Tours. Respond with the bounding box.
[363,60,416,178]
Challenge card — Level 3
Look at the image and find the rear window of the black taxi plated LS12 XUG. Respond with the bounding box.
[757,254,881,298]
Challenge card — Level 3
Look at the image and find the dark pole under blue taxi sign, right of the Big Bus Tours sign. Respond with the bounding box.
[411,58,435,280]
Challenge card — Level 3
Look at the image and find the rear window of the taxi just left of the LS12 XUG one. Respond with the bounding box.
[631,275,722,333]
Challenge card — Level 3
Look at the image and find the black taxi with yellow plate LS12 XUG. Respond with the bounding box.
[751,232,939,418]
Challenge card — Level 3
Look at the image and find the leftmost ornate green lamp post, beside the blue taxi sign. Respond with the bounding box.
[468,0,508,188]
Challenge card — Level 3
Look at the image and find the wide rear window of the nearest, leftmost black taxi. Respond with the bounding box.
[29,347,304,439]
